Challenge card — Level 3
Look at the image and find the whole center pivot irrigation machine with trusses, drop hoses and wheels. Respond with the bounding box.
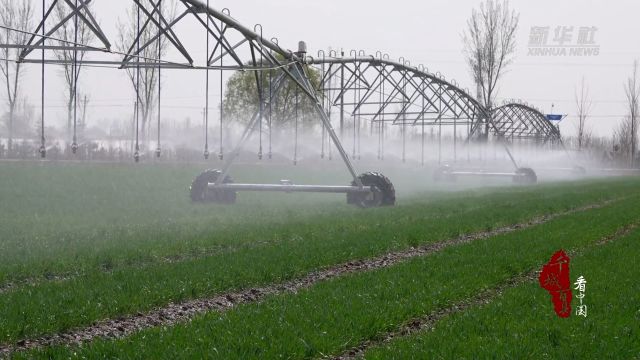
[0,0,560,207]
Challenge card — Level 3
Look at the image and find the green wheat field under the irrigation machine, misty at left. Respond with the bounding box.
[0,162,640,359]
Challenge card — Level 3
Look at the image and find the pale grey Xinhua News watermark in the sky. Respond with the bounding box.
[528,26,600,56]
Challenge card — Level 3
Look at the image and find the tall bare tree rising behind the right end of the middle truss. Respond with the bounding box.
[463,0,520,134]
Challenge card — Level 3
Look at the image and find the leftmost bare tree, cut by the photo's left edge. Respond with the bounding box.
[0,0,34,152]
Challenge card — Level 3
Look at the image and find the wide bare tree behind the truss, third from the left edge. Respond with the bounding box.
[116,1,175,150]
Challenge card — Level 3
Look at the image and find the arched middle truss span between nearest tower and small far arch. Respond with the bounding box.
[305,51,488,161]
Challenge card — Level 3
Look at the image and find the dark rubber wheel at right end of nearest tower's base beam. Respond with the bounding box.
[347,172,396,208]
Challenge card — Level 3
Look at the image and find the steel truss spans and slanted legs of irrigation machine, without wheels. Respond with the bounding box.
[0,0,560,172]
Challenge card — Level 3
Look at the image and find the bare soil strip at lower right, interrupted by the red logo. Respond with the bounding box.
[333,223,638,360]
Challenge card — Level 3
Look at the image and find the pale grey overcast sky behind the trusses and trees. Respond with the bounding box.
[8,0,640,136]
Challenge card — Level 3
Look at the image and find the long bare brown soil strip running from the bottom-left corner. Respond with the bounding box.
[0,197,626,357]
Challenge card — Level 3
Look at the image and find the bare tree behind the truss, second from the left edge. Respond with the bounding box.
[54,2,95,146]
